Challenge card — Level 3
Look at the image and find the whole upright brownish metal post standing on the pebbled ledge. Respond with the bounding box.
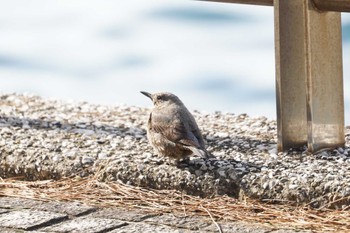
[274,0,345,152]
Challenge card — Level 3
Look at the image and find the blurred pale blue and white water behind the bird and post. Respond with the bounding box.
[0,0,350,124]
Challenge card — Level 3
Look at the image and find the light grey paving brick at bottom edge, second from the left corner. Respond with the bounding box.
[42,217,127,233]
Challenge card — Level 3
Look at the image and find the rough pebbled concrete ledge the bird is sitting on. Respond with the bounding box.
[0,94,350,207]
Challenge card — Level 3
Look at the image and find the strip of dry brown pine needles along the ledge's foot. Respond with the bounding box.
[0,177,350,232]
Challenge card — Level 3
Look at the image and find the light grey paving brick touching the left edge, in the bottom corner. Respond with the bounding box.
[0,209,68,230]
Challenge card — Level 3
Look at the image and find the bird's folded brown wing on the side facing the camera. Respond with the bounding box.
[151,113,201,148]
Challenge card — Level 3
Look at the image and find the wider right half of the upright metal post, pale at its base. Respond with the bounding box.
[305,0,344,152]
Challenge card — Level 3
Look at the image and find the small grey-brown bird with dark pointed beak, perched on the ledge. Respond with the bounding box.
[141,91,210,162]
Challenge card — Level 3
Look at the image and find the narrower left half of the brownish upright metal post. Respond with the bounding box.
[274,0,307,151]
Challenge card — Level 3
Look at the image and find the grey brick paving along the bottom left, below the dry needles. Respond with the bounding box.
[0,197,309,233]
